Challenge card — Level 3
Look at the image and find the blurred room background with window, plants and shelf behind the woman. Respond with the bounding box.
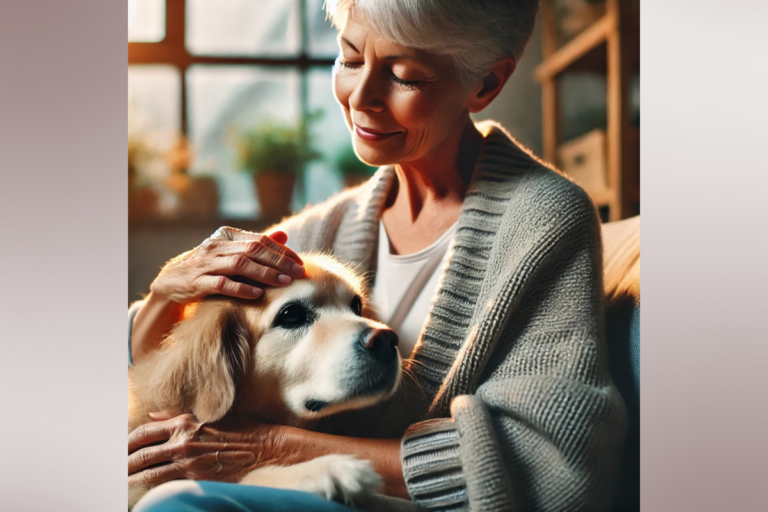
[128,0,640,302]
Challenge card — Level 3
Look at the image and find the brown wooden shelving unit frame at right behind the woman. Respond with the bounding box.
[535,0,640,221]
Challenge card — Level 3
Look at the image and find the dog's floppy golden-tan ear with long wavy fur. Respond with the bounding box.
[153,301,250,423]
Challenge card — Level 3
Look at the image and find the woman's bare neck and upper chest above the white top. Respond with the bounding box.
[382,115,483,254]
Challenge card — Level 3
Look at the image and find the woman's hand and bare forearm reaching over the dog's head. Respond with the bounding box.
[131,227,304,361]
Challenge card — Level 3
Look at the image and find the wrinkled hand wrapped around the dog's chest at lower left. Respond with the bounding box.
[128,413,280,487]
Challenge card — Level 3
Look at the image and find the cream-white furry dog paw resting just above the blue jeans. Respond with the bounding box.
[240,455,382,504]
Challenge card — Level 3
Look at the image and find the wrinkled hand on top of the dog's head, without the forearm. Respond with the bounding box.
[150,227,304,304]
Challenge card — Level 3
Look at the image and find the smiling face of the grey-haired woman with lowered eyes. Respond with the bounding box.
[333,11,471,166]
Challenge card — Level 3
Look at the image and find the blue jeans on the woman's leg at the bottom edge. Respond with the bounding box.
[133,480,352,512]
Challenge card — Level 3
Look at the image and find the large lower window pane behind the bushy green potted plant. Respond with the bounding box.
[187,66,301,218]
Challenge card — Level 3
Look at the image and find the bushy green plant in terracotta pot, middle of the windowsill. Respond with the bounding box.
[240,122,320,219]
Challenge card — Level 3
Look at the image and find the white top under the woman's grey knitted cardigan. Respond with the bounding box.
[371,221,458,358]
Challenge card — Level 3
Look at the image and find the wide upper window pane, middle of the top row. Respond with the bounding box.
[186,0,301,56]
